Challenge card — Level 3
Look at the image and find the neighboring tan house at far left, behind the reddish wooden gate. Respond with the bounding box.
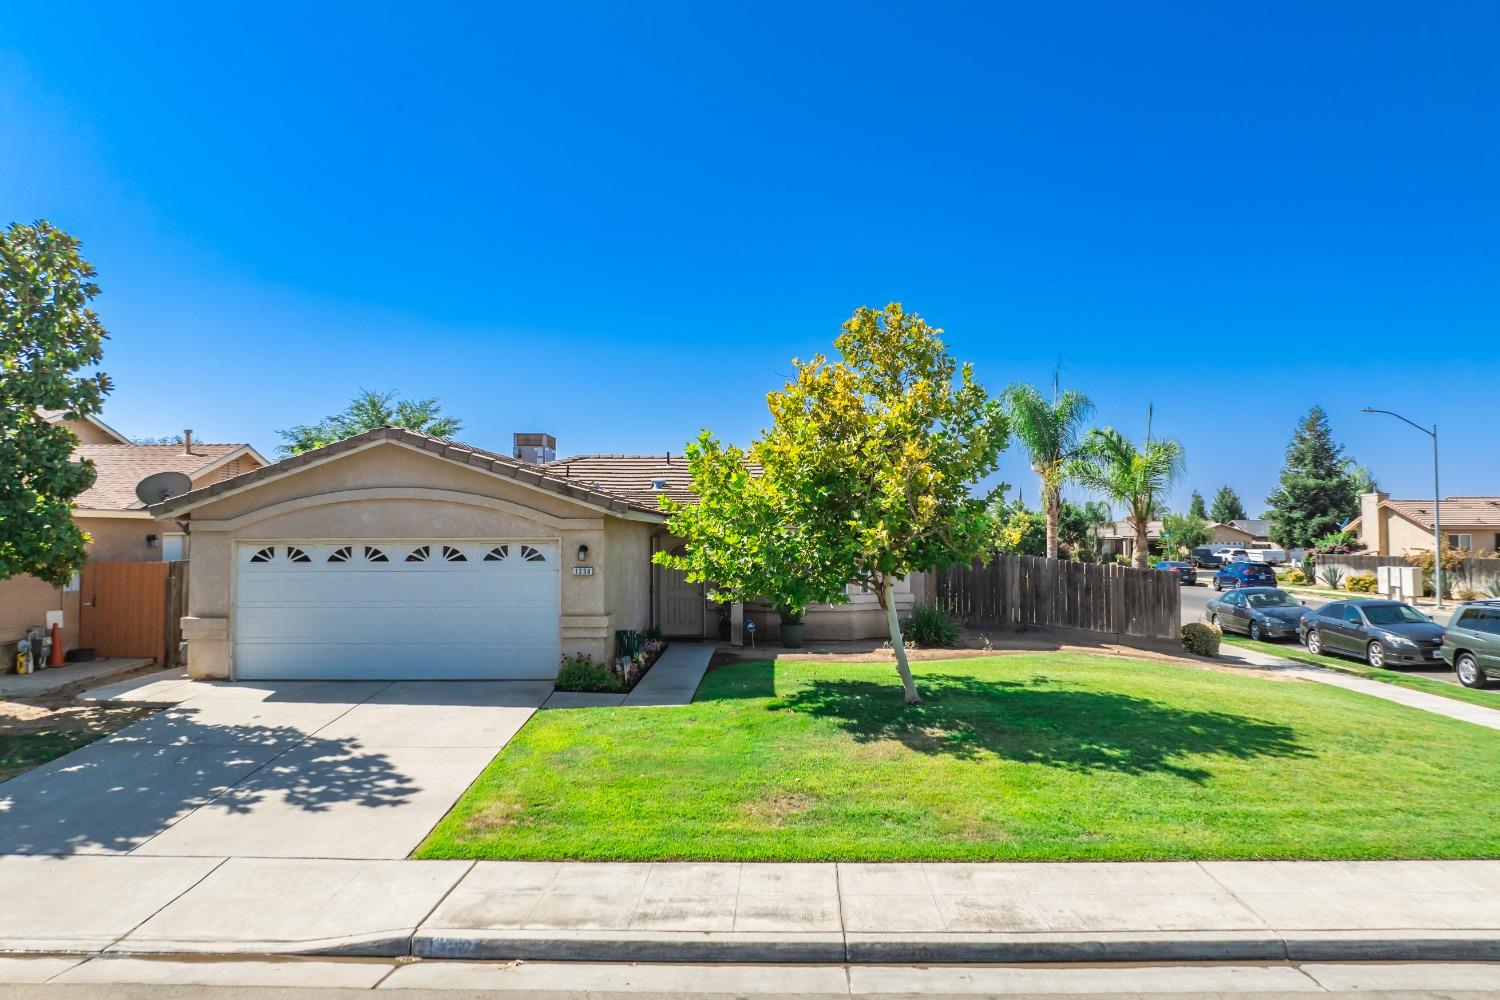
[0,412,266,649]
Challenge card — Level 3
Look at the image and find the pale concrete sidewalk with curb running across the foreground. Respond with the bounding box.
[0,855,1500,964]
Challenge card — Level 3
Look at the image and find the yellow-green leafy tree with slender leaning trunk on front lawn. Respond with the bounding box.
[656,303,1008,705]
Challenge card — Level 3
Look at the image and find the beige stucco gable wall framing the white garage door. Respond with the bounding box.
[170,442,653,678]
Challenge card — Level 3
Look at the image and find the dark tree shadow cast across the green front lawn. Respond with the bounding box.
[768,673,1316,783]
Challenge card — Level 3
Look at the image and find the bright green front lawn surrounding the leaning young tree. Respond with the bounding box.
[416,654,1500,861]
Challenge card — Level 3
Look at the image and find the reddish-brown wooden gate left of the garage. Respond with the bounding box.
[78,562,171,664]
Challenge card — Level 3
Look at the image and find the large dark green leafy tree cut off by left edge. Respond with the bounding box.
[0,222,111,586]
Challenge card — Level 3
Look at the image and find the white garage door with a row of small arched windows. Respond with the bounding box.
[234,540,558,681]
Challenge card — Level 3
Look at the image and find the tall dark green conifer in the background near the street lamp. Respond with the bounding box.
[1266,406,1359,549]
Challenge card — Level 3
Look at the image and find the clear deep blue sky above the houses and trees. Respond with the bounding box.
[0,3,1500,514]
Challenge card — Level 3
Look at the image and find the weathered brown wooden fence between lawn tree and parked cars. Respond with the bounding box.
[933,555,1182,639]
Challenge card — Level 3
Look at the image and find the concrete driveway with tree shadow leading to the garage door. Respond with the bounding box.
[0,681,552,859]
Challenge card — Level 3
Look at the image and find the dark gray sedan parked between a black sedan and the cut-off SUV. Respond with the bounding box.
[1302,598,1443,667]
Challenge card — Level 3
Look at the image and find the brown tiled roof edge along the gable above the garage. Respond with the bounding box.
[150,427,660,517]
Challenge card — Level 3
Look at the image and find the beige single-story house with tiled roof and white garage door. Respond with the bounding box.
[152,427,921,679]
